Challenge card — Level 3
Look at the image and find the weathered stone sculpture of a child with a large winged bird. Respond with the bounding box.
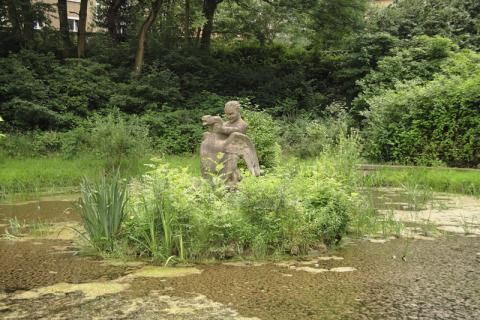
[200,101,260,187]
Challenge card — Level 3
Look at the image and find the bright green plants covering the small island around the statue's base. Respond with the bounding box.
[76,131,361,262]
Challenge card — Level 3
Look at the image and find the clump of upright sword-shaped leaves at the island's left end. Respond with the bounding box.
[78,171,128,251]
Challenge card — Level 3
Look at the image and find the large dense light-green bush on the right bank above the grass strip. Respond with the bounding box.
[365,51,480,166]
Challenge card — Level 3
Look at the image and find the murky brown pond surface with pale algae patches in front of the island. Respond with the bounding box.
[0,236,480,319]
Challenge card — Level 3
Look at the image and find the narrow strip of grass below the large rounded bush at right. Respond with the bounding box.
[363,167,480,197]
